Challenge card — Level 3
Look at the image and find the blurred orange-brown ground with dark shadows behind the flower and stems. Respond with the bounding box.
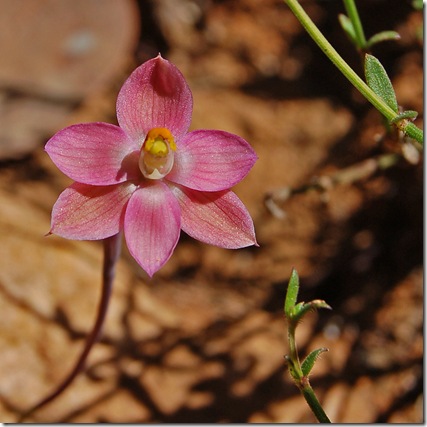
[0,0,423,423]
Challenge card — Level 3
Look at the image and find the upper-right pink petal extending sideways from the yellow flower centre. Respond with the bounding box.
[167,130,257,191]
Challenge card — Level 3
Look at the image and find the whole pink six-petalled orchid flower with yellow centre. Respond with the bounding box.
[45,55,257,276]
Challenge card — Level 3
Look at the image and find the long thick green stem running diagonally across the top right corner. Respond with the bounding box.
[284,0,423,144]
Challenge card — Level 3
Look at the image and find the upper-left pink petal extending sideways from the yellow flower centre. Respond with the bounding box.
[45,123,138,185]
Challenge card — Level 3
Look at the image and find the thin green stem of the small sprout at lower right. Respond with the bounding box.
[287,321,331,423]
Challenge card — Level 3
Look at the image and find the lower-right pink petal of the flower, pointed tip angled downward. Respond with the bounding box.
[171,186,258,249]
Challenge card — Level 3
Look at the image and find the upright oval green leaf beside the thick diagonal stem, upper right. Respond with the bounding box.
[365,54,398,113]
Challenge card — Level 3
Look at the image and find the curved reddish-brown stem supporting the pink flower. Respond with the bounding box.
[18,233,121,422]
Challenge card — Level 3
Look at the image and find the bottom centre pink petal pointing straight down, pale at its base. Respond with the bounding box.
[124,182,181,277]
